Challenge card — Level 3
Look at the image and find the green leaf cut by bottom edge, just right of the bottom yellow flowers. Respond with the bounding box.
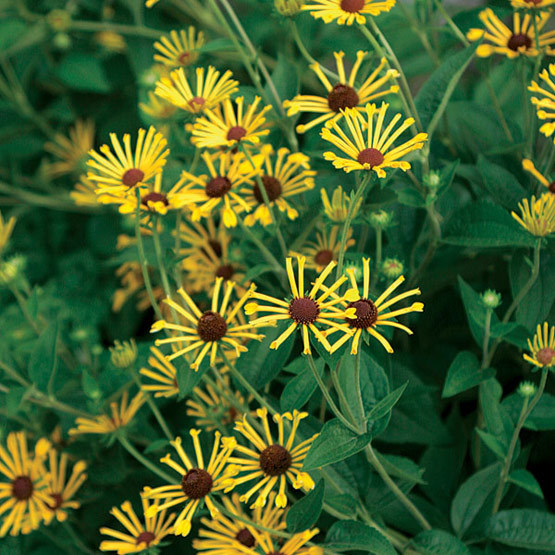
[325,520,396,555]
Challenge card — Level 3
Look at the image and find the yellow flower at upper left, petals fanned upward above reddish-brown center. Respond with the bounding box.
[87,126,170,196]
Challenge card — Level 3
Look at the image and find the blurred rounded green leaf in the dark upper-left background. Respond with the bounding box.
[56,52,110,93]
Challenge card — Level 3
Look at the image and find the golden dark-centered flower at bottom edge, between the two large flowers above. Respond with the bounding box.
[193,492,286,555]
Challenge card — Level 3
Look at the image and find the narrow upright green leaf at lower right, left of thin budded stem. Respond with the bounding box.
[451,463,501,537]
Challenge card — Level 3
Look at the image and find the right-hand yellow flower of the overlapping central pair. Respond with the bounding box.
[332,258,424,355]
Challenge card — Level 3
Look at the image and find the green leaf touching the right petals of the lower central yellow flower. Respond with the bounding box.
[303,418,372,471]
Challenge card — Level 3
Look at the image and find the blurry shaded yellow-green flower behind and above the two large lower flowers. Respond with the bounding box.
[186,376,245,432]
